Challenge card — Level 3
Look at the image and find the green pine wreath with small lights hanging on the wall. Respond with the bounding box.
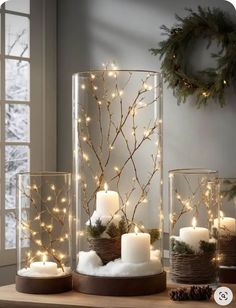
[150,7,236,107]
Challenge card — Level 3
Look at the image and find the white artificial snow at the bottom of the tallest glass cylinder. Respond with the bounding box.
[77,250,163,277]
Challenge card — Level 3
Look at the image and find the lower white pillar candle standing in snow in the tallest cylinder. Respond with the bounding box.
[121,229,151,263]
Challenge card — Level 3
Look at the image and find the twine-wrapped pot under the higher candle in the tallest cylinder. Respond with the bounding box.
[88,237,121,265]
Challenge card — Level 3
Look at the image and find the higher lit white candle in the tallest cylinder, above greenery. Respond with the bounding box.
[96,184,119,216]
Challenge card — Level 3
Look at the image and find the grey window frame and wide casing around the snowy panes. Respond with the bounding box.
[0,0,57,266]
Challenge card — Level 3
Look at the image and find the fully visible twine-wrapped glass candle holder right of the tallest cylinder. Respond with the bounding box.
[169,169,219,284]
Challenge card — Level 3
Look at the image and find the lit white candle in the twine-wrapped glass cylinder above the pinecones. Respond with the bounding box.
[179,218,209,250]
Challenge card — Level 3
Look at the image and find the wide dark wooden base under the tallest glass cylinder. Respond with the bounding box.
[73,272,166,296]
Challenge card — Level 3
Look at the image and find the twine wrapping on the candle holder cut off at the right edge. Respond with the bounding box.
[219,235,236,273]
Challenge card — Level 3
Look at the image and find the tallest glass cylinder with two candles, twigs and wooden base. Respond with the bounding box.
[73,67,166,296]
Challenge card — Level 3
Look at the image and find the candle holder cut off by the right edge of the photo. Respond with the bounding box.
[218,178,236,283]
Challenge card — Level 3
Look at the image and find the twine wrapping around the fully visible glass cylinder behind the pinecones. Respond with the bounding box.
[171,253,216,284]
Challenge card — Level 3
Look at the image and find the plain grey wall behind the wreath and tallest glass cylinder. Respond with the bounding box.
[58,0,236,231]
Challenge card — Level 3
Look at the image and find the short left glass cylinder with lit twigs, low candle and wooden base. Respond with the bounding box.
[16,172,72,294]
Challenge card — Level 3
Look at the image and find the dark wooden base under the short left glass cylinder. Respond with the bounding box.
[16,274,72,294]
